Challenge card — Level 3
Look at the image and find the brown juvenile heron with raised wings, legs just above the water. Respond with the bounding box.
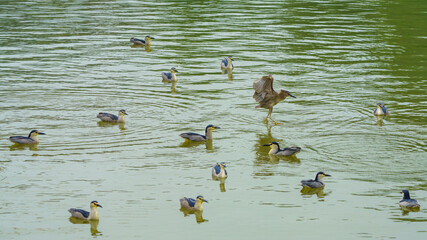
[253,74,296,124]
